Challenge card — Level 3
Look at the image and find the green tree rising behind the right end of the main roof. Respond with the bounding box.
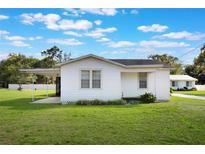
[148,54,183,74]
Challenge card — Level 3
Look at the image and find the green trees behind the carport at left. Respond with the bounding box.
[0,46,71,83]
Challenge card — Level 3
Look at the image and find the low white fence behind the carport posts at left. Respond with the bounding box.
[9,84,56,90]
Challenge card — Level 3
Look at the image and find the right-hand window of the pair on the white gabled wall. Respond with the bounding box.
[92,70,101,88]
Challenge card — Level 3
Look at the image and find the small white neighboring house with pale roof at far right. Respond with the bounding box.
[170,75,197,90]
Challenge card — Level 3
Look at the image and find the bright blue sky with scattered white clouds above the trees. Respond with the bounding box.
[0,9,205,64]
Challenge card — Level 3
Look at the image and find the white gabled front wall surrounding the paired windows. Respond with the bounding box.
[61,58,122,103]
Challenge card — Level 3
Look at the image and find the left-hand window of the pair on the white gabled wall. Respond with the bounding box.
[81,70,90,88]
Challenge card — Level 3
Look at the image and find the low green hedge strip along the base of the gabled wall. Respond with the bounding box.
[74,99,127,105]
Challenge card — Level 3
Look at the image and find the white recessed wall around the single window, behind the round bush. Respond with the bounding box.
[121,68,170,100]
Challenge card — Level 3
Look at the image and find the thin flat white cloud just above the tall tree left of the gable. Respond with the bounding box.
[48,39,84,46]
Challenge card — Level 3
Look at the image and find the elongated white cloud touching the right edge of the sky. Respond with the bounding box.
[153,31,205,40]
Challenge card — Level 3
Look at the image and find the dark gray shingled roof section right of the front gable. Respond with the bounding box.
[109,59,169,67]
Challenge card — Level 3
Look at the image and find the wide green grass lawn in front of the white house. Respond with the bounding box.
[0,89,205,144]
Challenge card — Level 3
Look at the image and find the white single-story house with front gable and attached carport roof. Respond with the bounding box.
[21,54,170,103]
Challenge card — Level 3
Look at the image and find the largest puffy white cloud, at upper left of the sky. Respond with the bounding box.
[21,13,92,30]
